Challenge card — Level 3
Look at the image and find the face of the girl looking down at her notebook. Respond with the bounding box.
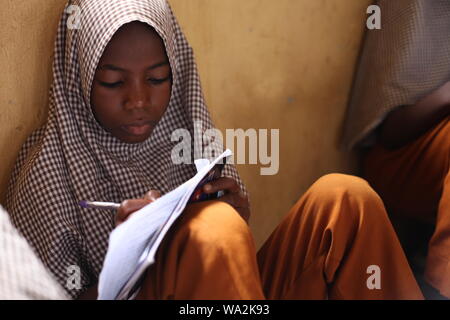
[91,22,172,143]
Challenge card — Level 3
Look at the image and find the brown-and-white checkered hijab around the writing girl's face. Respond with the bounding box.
[7,0,244,297]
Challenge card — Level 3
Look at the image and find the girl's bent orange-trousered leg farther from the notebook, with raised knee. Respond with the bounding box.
[258,174,423,299]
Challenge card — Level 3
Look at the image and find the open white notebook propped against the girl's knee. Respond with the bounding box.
[98,150,231,300]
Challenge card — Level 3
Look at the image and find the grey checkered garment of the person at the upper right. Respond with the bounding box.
[344,0,450,148]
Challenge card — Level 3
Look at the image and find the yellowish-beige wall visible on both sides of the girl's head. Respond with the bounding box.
[0,0,371,246]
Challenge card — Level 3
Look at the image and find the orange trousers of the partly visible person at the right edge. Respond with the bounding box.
[364,117,450,298]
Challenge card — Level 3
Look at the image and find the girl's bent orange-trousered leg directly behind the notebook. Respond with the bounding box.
[137,201,264,300]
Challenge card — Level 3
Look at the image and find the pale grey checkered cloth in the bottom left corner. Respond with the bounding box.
[0,207,67,300]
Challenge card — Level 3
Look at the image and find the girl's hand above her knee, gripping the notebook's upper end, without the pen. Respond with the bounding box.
[203,177,250,223]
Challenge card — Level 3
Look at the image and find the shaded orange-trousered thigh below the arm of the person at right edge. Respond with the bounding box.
[363,119,450,223]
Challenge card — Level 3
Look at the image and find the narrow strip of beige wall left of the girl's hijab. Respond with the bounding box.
[0,0,66,201]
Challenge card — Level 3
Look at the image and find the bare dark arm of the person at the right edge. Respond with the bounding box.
[379,81,450,149]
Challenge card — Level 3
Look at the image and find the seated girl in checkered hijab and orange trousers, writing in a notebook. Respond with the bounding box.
[7,0,422,299]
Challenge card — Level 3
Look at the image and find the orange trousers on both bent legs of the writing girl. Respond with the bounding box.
[137,174,423,300]
